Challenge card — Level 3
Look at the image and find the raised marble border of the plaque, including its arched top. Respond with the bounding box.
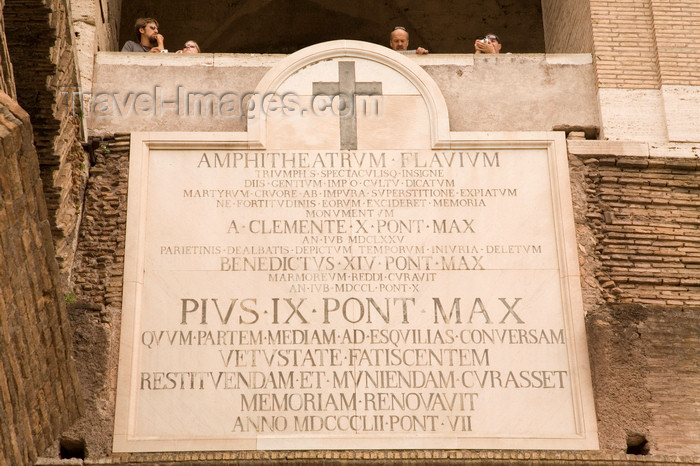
[113,40,599,452]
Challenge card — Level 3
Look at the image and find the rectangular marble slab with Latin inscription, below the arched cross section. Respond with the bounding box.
[114,141,597,451]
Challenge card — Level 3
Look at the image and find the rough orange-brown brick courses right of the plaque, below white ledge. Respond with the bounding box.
[587,157,700,306]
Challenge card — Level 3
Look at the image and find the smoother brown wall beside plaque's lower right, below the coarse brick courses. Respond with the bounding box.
[587,304,700,458]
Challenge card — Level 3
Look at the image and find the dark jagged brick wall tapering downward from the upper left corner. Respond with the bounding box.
[3,0,87,285]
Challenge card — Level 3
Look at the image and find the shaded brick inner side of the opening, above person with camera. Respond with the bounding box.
[542,0,593,53]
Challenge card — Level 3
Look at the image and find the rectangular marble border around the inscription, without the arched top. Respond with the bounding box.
[113,131,599,452]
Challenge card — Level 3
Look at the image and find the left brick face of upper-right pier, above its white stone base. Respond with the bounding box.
[590,0,660,89]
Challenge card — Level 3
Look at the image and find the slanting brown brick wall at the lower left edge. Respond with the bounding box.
[0,93,80,465]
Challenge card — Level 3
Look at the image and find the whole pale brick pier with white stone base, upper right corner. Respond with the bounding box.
[590,0,700,143]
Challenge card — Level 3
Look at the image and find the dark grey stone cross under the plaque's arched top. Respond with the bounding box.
[313,61,382,150]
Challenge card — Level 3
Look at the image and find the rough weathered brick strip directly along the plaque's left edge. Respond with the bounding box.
[41,135,129,458]
